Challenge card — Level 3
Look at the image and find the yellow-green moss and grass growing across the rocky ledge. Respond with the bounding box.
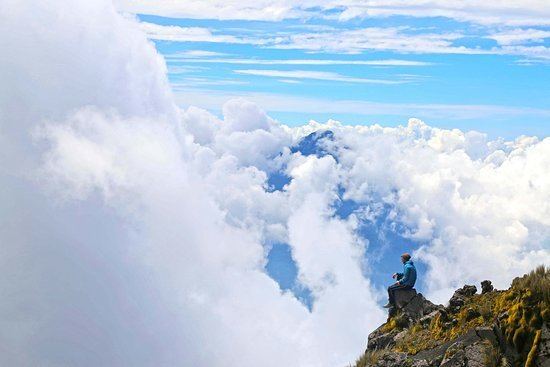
[386,266,550,367]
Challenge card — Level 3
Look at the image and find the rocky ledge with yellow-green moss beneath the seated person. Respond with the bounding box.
[355,267,550,367]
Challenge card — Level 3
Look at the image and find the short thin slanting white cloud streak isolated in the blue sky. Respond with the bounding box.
[234,69,407,84]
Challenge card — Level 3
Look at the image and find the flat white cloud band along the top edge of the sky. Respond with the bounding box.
[117,0,550,25]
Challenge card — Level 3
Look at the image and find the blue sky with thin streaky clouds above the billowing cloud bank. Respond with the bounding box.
[138,9,550,138]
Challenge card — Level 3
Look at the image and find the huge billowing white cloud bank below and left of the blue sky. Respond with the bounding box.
[0,1,550,366]
